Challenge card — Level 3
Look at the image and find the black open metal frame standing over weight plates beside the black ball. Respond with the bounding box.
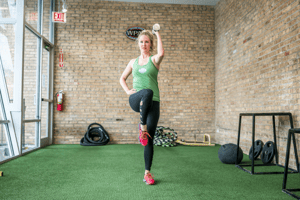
[235,113,299,175]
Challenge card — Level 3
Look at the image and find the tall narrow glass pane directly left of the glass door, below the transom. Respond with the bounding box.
[22,28,41,152]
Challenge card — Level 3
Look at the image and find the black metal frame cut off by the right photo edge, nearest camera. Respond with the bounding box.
[282,128,300,199]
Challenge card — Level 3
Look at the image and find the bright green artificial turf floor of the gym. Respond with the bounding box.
[0,144,300,200]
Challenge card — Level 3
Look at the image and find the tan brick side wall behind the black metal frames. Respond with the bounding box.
[215,0,300,164]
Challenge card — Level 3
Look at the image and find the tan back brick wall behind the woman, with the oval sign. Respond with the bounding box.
[54,0,215,144]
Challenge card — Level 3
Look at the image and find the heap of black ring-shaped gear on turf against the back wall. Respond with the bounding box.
[80,123,109,146]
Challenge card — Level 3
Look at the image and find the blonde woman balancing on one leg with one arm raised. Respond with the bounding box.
[120,27,164,185]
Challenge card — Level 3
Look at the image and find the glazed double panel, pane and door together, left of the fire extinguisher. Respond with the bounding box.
[22,28,53,151]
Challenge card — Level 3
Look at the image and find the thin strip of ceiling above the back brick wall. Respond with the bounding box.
[102,0,220,6]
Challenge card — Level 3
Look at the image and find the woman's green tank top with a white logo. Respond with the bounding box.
[132,56,160,102]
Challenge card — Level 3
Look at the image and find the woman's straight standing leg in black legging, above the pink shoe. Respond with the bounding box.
[144,101,160,173]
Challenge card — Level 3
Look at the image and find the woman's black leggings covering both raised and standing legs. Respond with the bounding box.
[129,89,159,171]
